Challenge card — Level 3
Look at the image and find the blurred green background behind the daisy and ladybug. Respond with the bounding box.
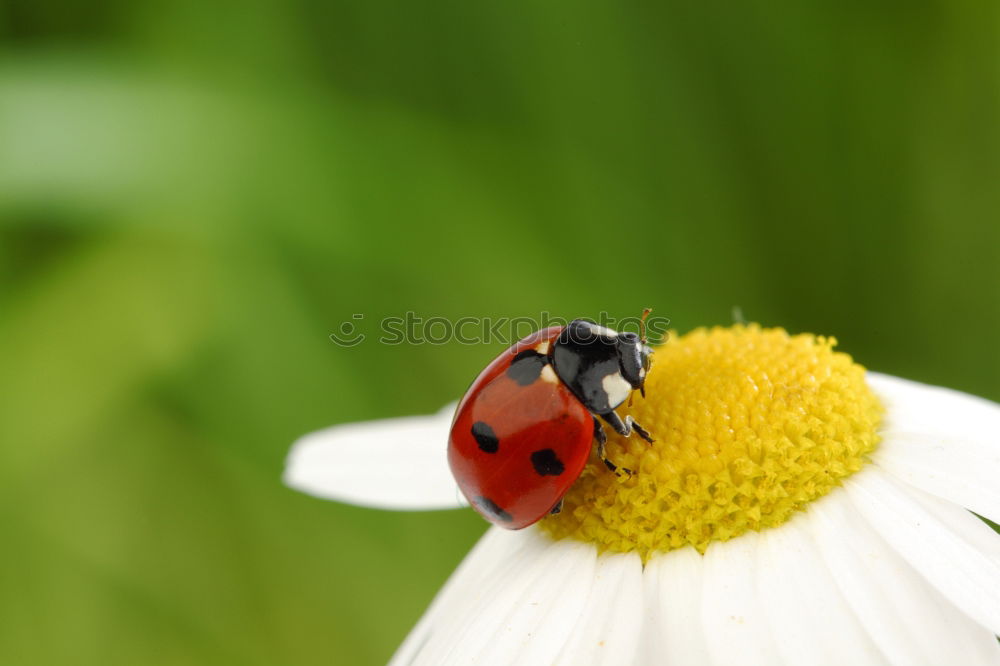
[0,0,1000,665]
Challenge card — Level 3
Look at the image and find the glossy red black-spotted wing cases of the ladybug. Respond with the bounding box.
[448,327,594,529]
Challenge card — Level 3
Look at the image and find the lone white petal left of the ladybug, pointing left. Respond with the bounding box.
[284,404,466,510]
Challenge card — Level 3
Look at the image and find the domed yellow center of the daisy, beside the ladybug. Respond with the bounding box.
[541,325,882,560]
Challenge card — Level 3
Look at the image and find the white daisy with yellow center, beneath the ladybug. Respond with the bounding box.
[285,326,1000,666]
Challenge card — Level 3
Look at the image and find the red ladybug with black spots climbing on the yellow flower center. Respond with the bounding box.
[448,310,653,530]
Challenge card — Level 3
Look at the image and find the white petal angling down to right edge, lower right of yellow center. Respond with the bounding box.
[844,468,1000,634]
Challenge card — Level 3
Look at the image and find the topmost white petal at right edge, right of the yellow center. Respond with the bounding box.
[868,372,1000,521]
